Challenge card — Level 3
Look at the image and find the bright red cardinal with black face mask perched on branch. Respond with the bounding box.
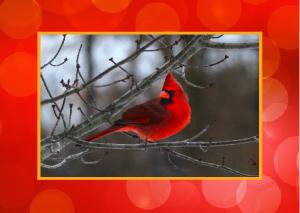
[86,73,191,142]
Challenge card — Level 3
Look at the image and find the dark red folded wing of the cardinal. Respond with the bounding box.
[117,99,170,126]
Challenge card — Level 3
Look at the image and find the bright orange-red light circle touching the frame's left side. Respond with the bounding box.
[0,52,36,97]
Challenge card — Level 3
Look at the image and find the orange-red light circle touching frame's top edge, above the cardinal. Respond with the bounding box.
[135,2,180,31]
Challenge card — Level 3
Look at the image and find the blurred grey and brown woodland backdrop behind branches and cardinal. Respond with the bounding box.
[40,35,259,177]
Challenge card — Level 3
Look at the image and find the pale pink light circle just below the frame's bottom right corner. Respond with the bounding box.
[236,176,281,213]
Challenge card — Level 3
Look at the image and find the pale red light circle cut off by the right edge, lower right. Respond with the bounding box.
[274,136,299,186]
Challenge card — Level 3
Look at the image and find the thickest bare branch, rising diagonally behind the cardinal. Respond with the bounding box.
[41,35,211,160]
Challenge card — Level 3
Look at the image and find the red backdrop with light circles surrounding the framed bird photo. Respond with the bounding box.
[0,0,299,213]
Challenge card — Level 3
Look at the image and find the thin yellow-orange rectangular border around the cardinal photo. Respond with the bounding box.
[37,31,263,180]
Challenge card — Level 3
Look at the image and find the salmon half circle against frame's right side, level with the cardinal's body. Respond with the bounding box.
[262,78,288,122]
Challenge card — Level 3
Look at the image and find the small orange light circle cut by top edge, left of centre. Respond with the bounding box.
[92,0,131,13]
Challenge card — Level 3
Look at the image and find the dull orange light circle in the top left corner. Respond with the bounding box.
[0,0,42,39]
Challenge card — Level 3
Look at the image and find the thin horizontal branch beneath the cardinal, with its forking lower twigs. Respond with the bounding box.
[41,135,258,177]
